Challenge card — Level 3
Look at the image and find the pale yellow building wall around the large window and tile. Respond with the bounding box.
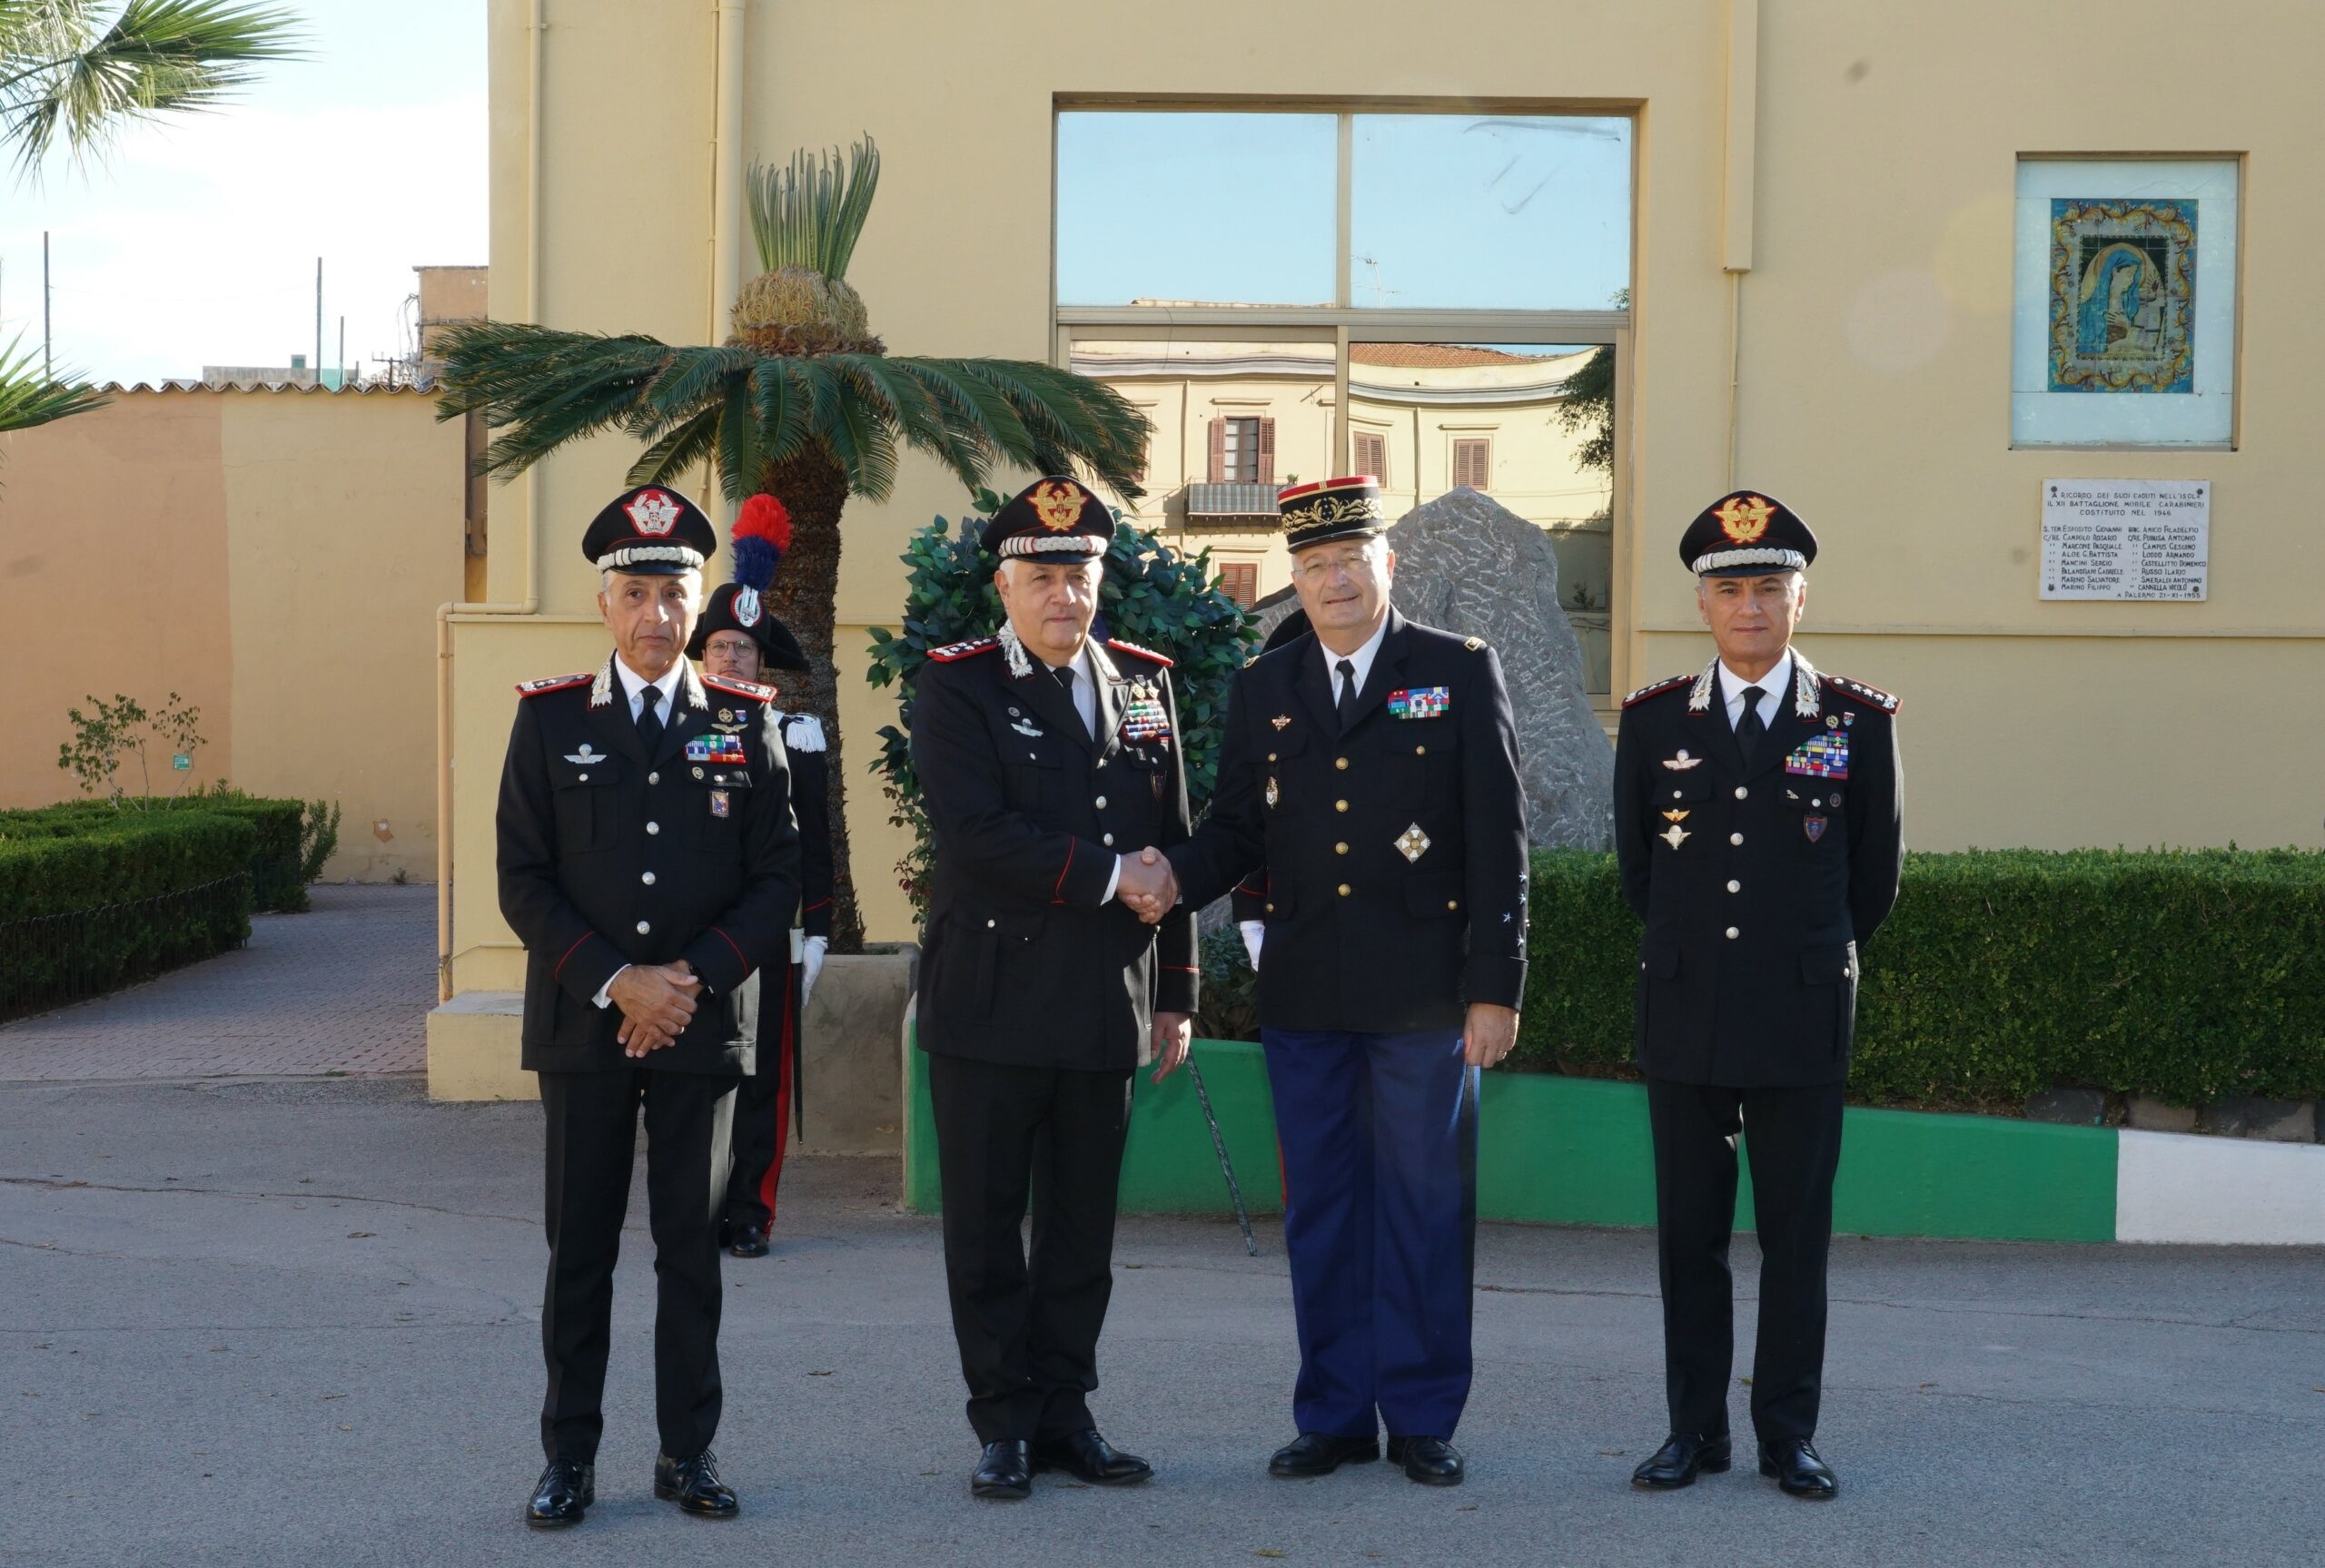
[456,0,2325,980]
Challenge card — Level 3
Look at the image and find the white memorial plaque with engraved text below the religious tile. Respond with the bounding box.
[2042,478,2211,599]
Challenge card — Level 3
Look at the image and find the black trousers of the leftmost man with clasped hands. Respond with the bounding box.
[539,1066,737,1464]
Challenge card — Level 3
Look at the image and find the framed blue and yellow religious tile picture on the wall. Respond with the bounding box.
[2011,155,2239,449]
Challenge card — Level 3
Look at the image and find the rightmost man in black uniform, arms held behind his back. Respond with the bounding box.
[1614,490,1905,1498]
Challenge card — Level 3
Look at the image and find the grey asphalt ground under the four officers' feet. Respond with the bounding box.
[0,1078,2325,1568]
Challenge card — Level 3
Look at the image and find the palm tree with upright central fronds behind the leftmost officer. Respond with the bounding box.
[437,137,1149,952]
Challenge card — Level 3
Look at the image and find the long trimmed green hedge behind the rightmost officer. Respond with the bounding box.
[1516,848,2325,1110]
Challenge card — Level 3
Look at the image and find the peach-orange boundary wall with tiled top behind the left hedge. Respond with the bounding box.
[0,390,462,881]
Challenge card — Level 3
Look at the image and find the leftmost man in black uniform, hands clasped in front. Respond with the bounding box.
[498,486,800,1526]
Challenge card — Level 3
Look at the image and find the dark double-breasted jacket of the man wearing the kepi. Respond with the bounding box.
[1172,608,1528,1034]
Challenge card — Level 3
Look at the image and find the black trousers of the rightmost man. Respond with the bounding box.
[1646,1078,1842,1443]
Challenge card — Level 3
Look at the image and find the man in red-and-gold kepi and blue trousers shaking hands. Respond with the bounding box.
[1170,476,1528,1486]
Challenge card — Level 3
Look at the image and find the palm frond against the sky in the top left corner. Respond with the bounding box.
[0,0,304,176]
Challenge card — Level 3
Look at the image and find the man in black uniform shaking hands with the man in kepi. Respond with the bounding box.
[905,478,1195,1498]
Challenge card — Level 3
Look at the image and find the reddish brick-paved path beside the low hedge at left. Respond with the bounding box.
[0,883,435,1080]
